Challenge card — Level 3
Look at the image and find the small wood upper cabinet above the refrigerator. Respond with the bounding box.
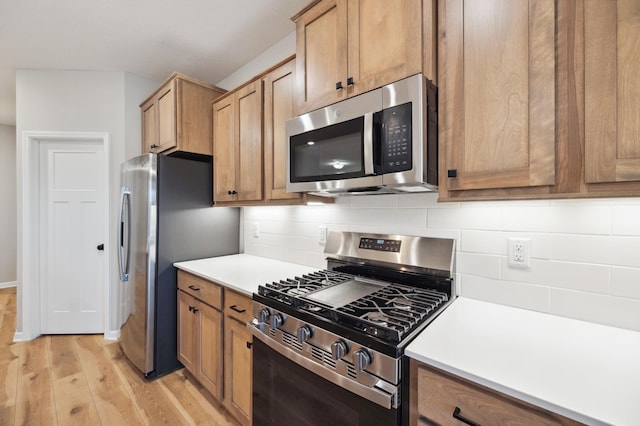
[140,73,225,155]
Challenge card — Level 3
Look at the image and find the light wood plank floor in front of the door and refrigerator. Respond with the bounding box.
[0,289,237,426]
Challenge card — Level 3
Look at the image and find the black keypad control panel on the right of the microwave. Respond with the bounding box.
[381,103,413,173]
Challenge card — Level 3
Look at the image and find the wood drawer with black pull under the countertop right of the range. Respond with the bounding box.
[410,360,580,425]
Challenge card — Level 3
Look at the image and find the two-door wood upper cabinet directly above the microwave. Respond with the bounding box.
[292,0,433,113]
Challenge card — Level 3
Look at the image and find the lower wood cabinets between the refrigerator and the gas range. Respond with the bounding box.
[178,270,253,425]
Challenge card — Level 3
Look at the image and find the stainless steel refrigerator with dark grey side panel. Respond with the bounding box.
[118,154,240,377]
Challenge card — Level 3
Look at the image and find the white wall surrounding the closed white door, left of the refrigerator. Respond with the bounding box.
[16,70,159,333]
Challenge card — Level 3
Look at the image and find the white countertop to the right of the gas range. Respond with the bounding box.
[405,297,640,426]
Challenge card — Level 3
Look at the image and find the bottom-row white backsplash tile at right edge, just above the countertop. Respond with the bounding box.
[551,289,640,330]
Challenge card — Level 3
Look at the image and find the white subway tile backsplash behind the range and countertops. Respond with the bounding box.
[244,194,640,330]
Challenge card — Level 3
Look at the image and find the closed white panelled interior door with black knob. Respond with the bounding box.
[40,140,108,334]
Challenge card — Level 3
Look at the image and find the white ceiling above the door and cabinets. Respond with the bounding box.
[0,0,310,125]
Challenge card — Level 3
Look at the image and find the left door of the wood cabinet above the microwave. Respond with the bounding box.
[296,0,350,113]
